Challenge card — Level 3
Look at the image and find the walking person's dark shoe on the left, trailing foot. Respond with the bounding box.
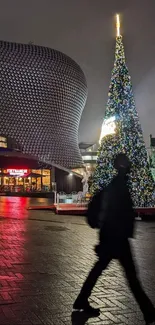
[73,298,100,317]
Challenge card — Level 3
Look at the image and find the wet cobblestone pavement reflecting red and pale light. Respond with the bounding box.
[0,196,155,325]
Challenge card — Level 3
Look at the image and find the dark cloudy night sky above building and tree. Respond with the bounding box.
[0,0,155,145]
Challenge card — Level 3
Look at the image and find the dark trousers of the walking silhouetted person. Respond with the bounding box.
[79,240,154,317]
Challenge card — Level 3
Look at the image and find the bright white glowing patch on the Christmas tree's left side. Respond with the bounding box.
[99,116,116,144]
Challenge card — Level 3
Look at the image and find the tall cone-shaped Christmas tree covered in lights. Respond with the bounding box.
[91,15,154,206]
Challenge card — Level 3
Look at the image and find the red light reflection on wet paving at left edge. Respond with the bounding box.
[0,208,30,316]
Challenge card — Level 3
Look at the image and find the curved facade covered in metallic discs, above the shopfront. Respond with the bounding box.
[0,41,87,168]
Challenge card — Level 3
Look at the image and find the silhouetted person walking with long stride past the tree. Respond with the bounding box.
[73,154,155,324]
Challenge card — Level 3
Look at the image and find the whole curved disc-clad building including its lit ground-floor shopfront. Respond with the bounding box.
[0,41,87,192]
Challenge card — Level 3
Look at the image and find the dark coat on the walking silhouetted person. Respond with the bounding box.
[97,170,134,255]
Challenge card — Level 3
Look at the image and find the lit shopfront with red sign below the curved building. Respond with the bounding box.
[0,168,51,192]
